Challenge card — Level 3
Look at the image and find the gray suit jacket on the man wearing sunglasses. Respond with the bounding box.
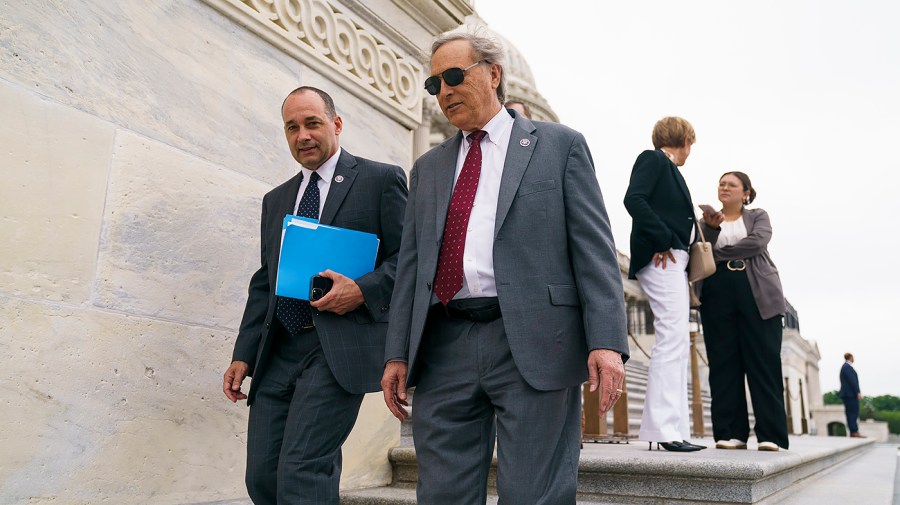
[385,115,628,391]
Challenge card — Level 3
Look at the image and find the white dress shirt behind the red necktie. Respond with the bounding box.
[453,107,513,299]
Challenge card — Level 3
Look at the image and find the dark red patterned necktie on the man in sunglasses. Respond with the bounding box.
[434,130,487,305]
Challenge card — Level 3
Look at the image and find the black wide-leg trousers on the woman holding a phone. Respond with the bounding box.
[700,263,788,449]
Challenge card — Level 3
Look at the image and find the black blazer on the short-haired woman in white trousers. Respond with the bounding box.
[625,149,696,279]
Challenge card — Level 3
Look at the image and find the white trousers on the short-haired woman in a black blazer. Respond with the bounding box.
[637,250,691,442]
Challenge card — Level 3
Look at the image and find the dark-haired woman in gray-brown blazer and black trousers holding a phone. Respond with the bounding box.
[698,172,788,451]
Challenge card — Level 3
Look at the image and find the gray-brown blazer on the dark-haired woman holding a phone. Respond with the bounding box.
[696,209,786,319]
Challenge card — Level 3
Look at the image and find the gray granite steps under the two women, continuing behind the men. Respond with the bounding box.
[341,436,874,505]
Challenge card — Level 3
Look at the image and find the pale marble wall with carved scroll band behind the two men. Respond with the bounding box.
[0,0,468,504]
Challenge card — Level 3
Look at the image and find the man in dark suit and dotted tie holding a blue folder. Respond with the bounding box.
[223,87,407,505]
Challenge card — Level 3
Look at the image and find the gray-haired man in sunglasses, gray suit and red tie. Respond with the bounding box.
[381,33,628,505]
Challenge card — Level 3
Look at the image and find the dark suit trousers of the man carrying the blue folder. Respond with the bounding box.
[247,320,363,505]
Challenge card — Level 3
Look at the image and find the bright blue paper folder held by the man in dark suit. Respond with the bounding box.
[275,214,379,300]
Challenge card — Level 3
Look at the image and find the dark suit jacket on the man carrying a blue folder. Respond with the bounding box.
[232,149,407,405]
